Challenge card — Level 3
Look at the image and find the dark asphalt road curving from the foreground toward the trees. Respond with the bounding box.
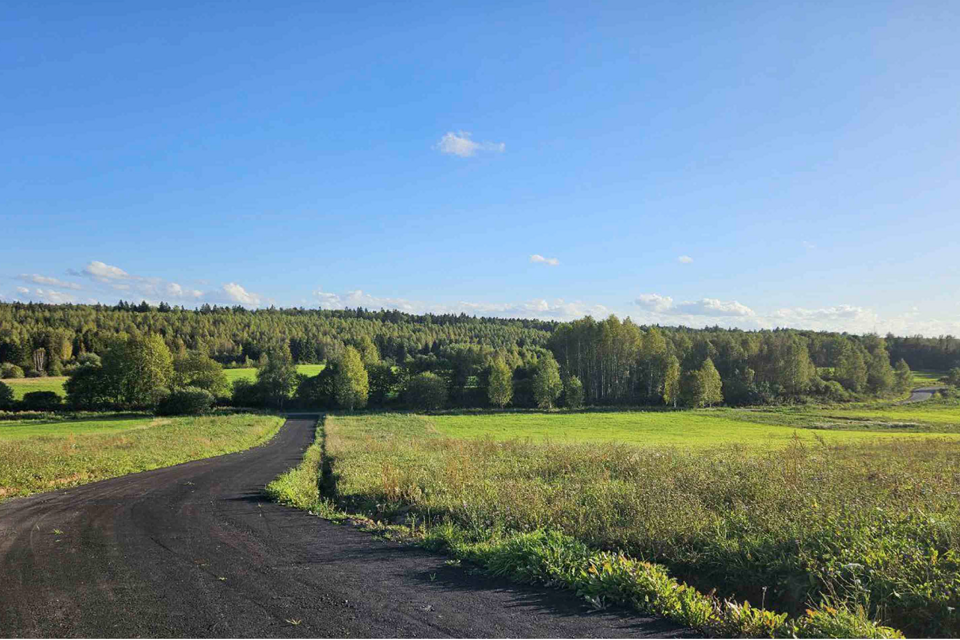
[0,418,689,637]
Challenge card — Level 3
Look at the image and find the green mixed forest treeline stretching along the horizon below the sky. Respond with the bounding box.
[0,302,960,407]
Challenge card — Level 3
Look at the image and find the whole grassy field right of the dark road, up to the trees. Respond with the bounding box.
[270,402,960,636]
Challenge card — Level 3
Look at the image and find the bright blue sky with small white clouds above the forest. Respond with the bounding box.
[0,1,960,335]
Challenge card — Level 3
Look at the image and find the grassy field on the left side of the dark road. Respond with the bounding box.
[0,414,283,501]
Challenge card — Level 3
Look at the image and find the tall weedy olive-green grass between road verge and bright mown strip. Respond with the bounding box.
[310,415,960,635]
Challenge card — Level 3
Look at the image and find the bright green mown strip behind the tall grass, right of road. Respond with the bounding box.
[418,406,960,448]
